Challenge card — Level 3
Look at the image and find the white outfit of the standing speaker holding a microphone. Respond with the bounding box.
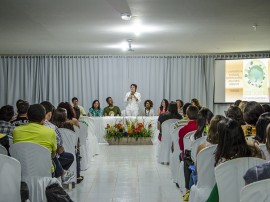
[124,92,141,116]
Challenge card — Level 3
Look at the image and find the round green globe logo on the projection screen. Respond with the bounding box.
[244,60,266,88]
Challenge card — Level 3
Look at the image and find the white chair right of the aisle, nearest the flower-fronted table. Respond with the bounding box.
[158,119,179,163]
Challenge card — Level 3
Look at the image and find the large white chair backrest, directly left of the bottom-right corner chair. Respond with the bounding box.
[215,157,266,202]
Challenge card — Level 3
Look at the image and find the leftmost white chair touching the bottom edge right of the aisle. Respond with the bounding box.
[189,145,217,202]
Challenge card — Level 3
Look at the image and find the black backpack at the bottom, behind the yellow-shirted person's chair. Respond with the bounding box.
[46,183,73,202]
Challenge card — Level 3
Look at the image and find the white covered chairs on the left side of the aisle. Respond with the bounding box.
[0,120,98,202]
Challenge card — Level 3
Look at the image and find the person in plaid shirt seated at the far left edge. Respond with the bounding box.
[0,105,15,144]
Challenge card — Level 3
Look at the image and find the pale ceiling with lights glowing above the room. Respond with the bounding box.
[0,0,270,55]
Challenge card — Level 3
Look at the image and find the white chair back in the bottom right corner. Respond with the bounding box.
[240,179,270,202]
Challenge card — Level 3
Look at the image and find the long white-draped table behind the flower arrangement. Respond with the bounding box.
[80,116,158,143]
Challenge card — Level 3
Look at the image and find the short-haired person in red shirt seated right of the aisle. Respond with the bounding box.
[178,105,199,156]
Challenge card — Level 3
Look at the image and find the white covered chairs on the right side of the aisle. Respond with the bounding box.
[158,120,270,202]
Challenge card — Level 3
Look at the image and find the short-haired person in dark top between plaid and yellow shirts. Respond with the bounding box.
[11,101,30,126]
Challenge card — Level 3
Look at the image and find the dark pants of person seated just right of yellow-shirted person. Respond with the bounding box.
[53,152,74,178]
